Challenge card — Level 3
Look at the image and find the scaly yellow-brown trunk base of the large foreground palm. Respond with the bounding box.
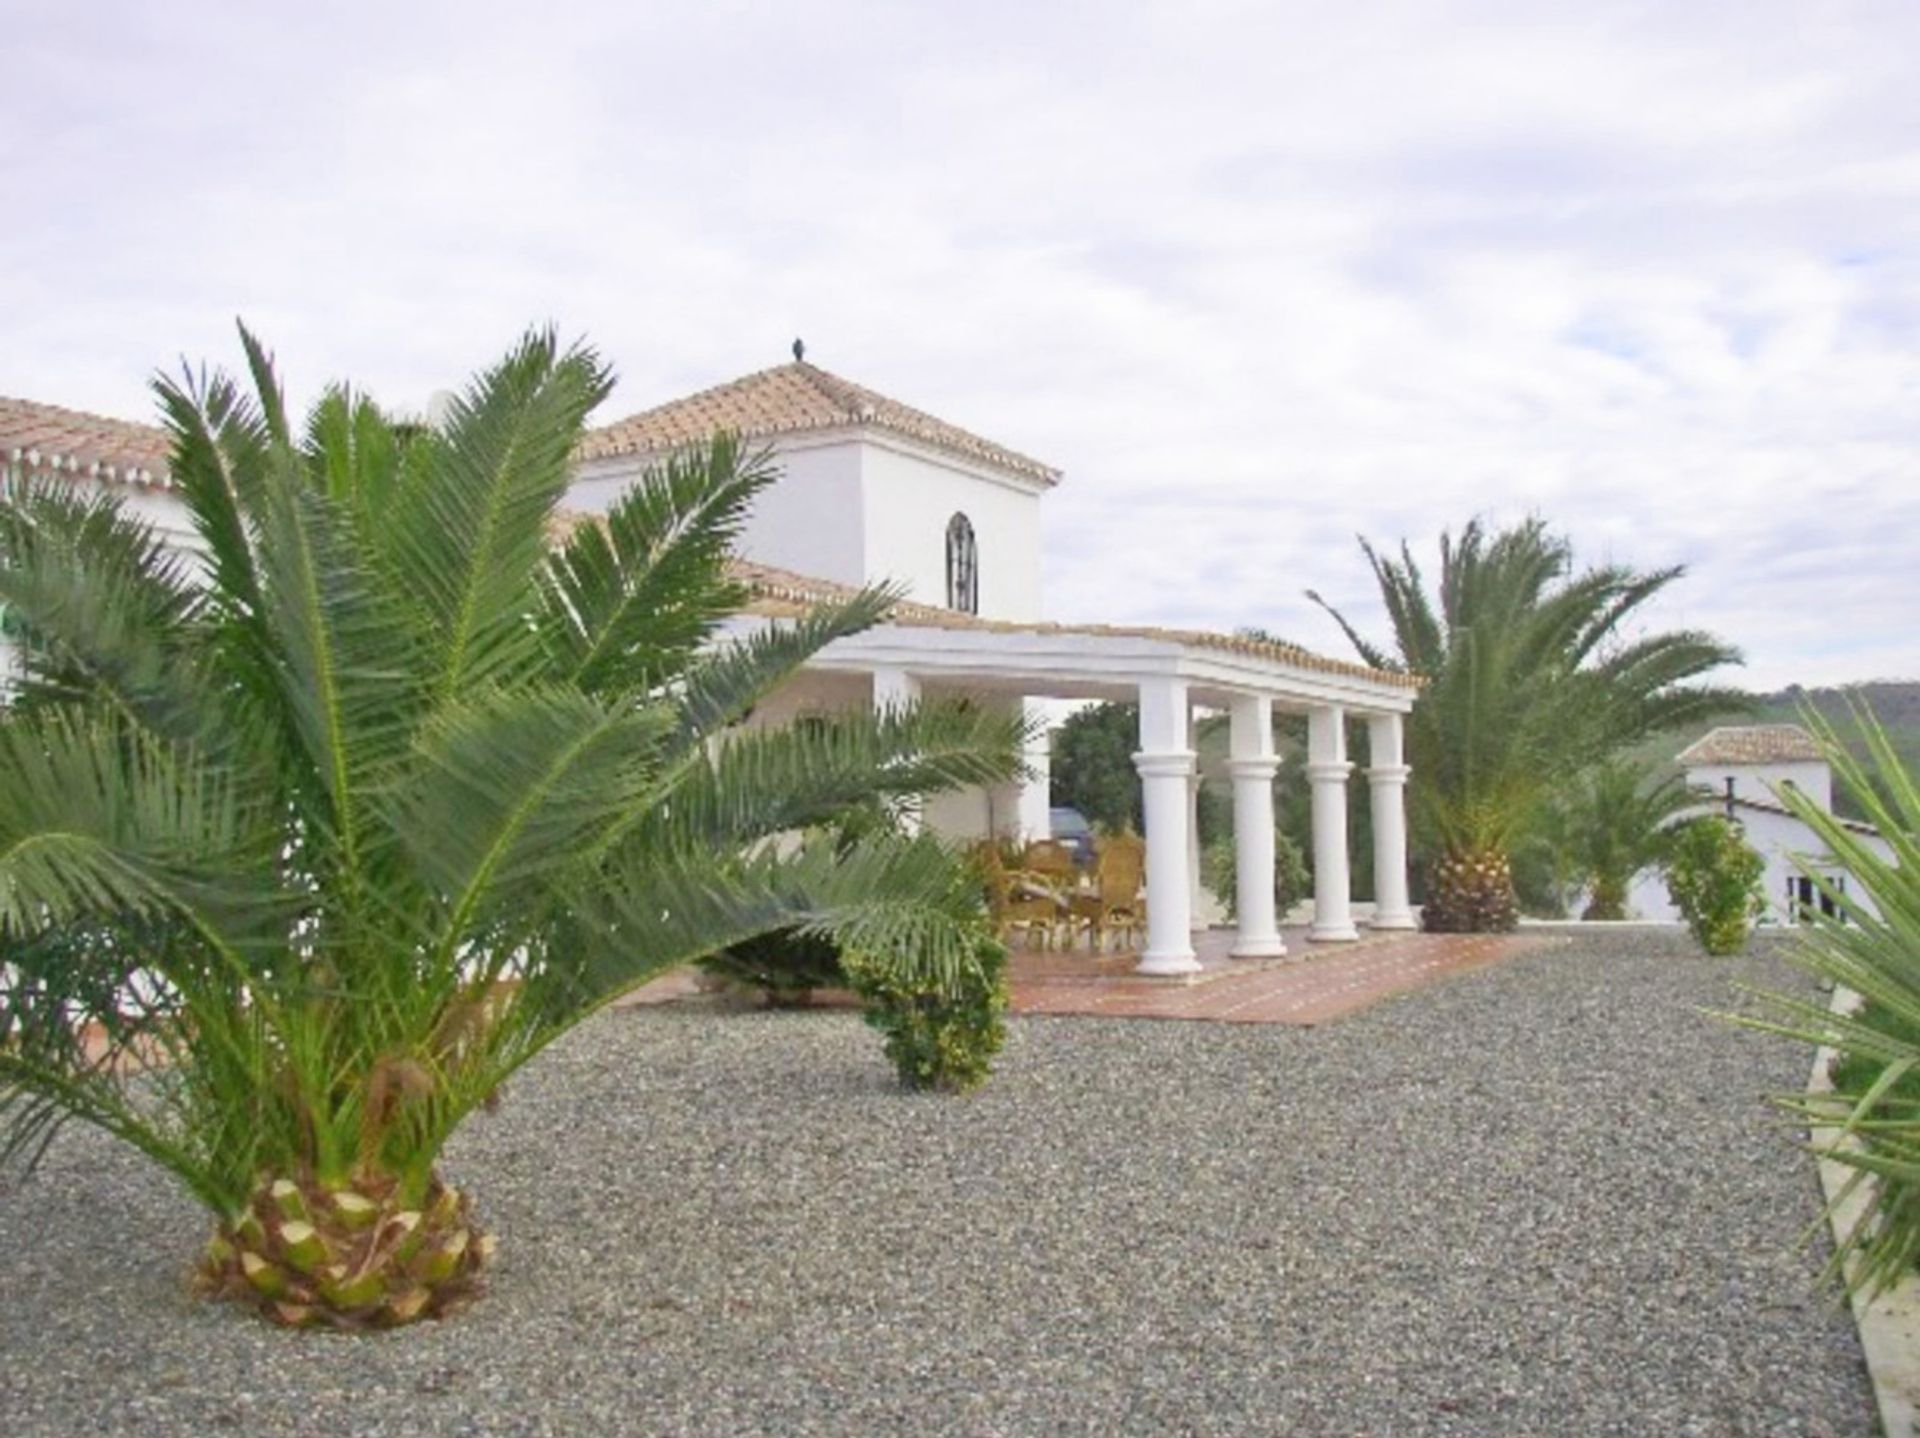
[202,1177,493,1329]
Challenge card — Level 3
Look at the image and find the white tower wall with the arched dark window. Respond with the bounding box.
[860,442,1043,620]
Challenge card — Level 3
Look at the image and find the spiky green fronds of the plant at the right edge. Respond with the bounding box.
[1749,707,1920,1294]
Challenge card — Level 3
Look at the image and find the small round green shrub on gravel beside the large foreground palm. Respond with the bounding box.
[847,931,1006,1092]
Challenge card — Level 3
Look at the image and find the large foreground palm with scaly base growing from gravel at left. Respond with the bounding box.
[0,330,1021,1325]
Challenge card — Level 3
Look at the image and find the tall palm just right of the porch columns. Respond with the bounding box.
[1309,518,1743,933]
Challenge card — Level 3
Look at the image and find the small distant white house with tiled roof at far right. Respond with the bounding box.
[1628,724,1893,923]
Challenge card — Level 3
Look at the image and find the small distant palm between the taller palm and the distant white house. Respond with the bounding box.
[1542,758,1695,922]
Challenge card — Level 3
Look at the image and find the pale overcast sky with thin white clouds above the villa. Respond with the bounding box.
[0,0,1920,687]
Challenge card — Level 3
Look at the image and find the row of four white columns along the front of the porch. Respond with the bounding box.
[1133,680,1413,973]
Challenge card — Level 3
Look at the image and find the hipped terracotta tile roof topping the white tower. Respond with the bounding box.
[576,361,1060,484]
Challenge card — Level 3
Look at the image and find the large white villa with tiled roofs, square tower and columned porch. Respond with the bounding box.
[0,359,1415,973]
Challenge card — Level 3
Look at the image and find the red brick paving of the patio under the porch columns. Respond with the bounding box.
[1010,931,1565,1025]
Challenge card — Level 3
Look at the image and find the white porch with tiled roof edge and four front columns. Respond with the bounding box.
[751,583,1417,973]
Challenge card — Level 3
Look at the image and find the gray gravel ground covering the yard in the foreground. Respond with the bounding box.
[0,933,1874,1438]
